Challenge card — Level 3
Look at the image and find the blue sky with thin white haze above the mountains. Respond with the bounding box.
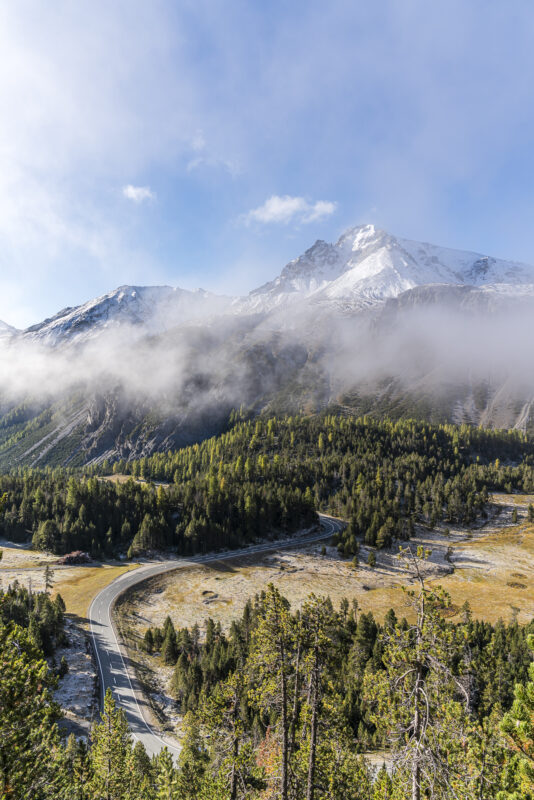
[0,0,534,326]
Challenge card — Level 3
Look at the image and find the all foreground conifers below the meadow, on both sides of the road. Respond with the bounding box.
[5,576,534,800]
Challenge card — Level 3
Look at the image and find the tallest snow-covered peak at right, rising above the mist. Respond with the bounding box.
[244,225,534,311]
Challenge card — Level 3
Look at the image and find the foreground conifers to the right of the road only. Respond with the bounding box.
[138,580,534,800]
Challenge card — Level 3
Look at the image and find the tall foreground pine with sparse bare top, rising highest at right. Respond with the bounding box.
[365,548,470,800]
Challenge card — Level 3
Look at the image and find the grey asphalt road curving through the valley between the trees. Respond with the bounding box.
[89,514,343,757]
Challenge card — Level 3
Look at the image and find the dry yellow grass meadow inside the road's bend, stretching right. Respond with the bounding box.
[120,495,534,635]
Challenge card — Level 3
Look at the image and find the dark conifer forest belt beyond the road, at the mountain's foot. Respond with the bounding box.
[0,415,534,557]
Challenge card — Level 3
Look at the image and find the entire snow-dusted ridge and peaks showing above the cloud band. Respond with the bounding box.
[12,225,534,345]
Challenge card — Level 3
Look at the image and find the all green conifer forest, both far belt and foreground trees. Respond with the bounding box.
[0,415,534,800]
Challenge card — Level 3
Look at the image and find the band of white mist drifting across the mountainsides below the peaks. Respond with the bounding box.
[0,292,534,438]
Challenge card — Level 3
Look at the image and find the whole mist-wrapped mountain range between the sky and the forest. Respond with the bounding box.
[0,220,534,468]
